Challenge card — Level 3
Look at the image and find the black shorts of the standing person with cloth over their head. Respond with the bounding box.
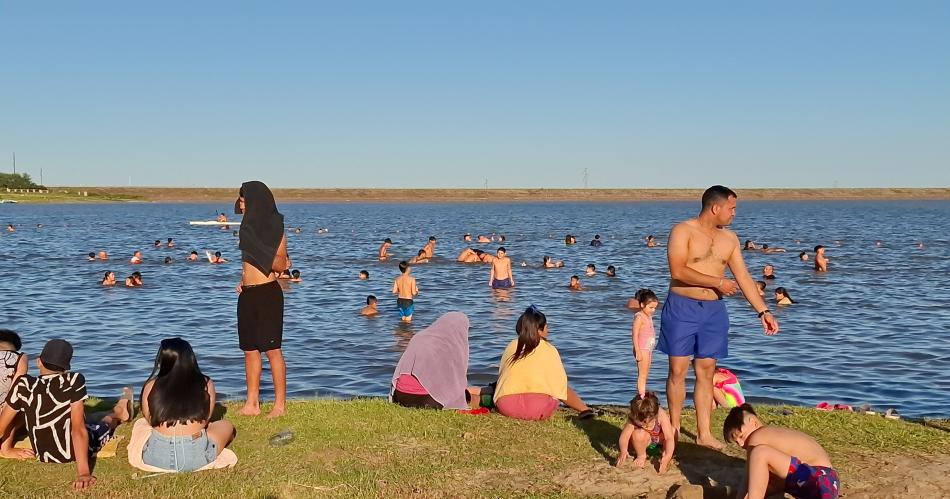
[238,281,284,352]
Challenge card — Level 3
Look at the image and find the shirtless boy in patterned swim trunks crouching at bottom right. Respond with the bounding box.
[722,404,841,499]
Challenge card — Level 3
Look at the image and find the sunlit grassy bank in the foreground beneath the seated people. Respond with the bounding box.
[0,399,950,498]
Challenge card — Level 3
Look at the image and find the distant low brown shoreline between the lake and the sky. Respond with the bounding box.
[0,186,950,204]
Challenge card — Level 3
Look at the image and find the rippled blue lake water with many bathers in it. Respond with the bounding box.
[0,200,950,417]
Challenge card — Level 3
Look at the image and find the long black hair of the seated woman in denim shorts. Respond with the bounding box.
[146,338,211,426]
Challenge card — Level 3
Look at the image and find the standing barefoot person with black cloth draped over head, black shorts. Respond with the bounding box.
[234,180,291,418]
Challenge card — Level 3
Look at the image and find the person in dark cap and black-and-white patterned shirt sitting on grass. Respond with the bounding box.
[0,339,132,489]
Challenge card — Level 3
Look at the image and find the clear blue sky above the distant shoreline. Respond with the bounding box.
[0,0,950,188]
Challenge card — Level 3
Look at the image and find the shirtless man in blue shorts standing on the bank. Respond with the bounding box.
[657,185,779,449]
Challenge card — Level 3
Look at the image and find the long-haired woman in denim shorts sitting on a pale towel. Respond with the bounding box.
[136,338,235,472]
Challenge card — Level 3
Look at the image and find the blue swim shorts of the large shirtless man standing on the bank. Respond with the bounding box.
[657,292,729,359]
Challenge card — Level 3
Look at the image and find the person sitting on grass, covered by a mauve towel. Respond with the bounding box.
[389,312,478,409]
